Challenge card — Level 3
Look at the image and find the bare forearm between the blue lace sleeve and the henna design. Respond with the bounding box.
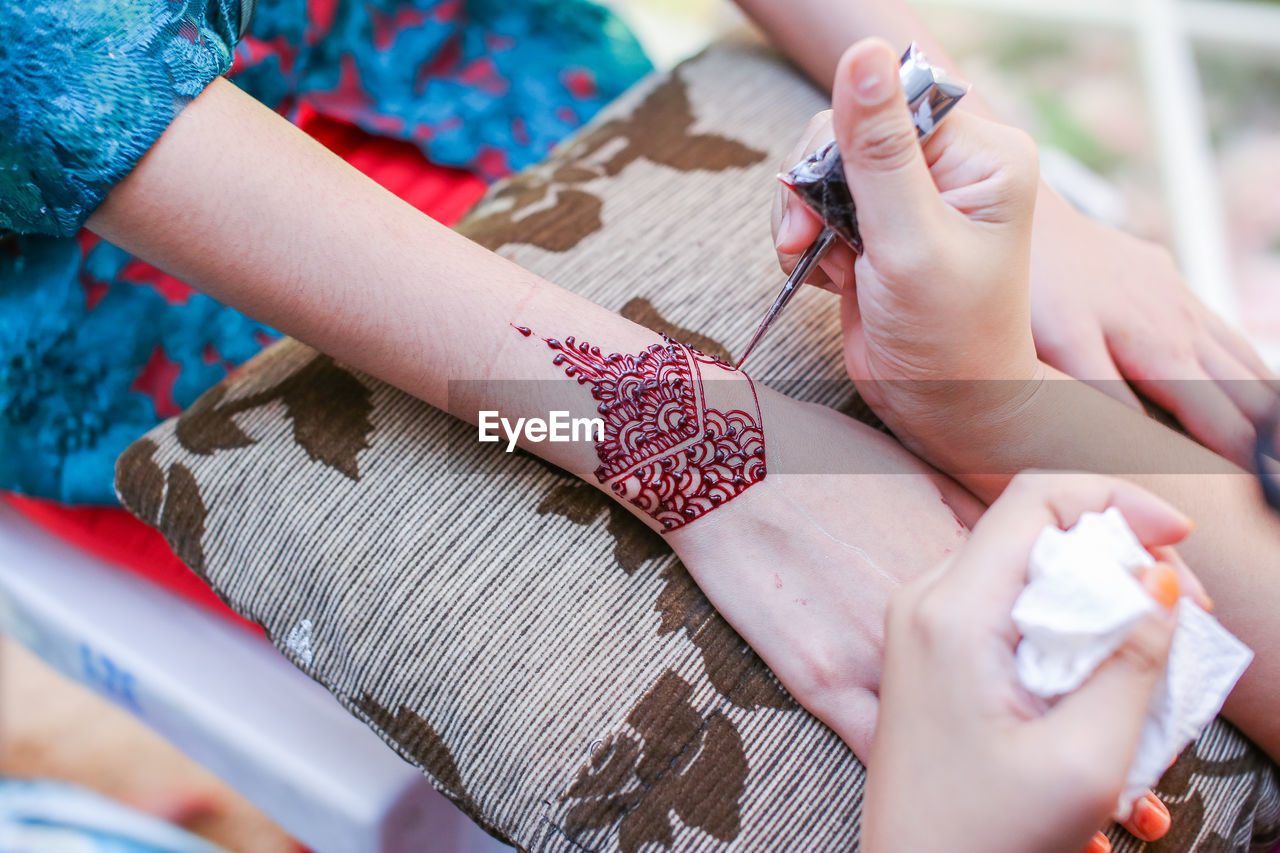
[90,81,659,491]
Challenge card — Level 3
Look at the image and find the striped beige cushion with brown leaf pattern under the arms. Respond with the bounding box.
[118,36,1280,853]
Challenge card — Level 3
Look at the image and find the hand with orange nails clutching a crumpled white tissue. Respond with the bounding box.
[861,473,1190,853]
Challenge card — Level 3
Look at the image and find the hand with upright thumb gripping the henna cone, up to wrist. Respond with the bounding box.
[783,38,1042,451]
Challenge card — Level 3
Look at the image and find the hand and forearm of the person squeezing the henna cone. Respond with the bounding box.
[808,40,1280,849]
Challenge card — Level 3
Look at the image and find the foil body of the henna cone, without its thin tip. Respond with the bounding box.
[780,42,969,255]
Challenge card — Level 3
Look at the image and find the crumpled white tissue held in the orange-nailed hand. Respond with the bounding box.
[1012,507,1253,820]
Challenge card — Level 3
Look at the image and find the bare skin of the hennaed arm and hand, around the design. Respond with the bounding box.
[90,81,982,757]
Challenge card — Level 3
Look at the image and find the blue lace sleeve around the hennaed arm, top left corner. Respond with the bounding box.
[0,0,241,237]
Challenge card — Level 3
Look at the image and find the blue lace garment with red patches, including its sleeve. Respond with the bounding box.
[0,0,649,503]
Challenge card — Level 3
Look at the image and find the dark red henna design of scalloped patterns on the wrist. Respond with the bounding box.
[513,327,765,532]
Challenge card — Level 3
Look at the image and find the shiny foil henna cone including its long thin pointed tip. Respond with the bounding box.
[737,42,969,369]
